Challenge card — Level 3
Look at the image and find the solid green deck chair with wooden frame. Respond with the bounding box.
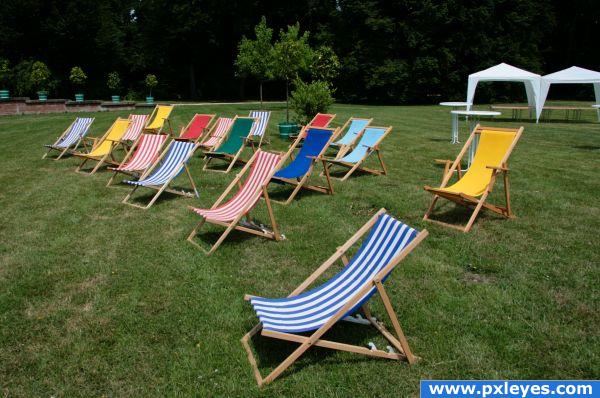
[203,116,256,173]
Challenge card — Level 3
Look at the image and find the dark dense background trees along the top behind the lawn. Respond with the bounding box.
[0,0,600,103]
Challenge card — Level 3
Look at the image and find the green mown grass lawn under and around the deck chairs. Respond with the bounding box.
[0,104,600,397]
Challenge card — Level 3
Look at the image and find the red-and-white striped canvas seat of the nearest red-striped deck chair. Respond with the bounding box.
[192,150,281,222]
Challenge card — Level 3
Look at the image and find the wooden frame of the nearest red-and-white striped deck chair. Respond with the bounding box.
[187,152,284,255]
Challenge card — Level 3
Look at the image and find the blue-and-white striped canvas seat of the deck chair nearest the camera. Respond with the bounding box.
[251,214,417,333]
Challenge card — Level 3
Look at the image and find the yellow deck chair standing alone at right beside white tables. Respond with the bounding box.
[423,124,523,232]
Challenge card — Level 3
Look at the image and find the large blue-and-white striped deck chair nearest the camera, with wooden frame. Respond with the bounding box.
[241,209,427,386]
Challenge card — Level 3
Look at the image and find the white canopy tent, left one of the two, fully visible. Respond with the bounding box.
[466,63,542,116]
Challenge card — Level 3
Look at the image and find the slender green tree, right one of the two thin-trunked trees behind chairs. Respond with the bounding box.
[273,23,313,122]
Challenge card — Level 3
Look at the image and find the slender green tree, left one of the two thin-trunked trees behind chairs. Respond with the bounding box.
[235,16,273,107]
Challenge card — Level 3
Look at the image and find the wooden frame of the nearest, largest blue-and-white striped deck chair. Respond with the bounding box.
[241,209,428,387]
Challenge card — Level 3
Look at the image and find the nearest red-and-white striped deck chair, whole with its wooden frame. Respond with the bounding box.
[187,149,283,255]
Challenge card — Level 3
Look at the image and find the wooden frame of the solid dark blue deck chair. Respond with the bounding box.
[271,127,339,205]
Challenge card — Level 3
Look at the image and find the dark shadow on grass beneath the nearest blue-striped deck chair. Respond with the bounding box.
[245,321,396,378]
